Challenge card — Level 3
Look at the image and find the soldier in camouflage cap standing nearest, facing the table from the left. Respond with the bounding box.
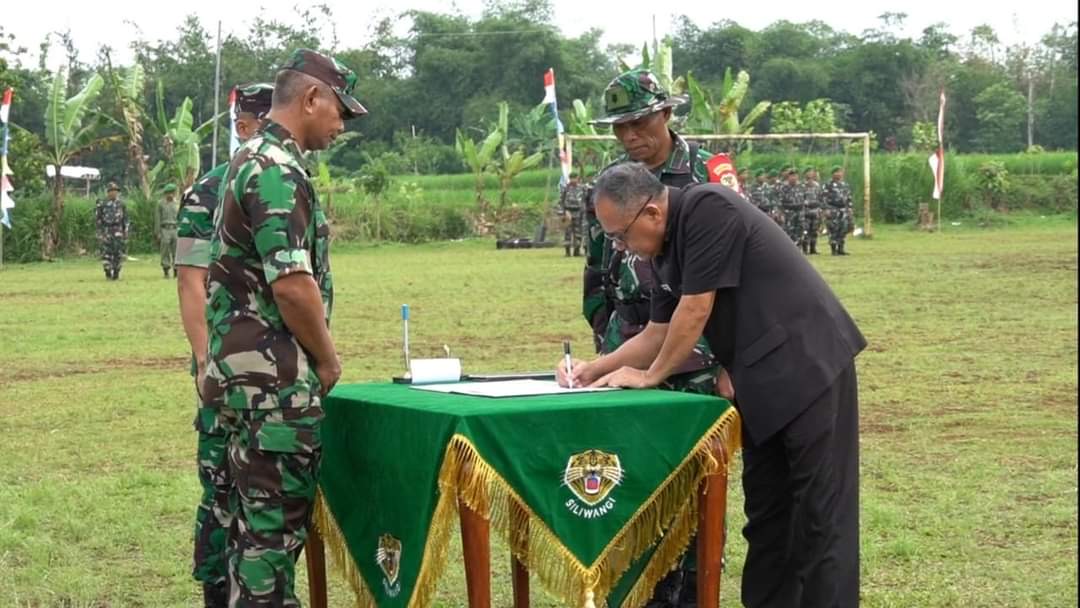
[200,50,367,608]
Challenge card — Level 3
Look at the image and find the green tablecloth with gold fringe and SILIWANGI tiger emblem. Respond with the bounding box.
[316,384,740,608]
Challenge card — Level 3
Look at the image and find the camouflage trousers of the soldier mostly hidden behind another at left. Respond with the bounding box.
[191,404,237,586]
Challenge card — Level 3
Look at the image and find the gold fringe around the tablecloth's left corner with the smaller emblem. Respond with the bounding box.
[312,475,457,608]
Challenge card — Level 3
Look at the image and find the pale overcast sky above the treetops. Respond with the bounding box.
[0,0,1077,67]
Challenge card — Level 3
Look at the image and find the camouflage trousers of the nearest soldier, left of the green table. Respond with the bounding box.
[220,397,323,608]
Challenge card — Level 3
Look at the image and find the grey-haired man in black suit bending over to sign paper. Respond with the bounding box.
[558,163,866,607]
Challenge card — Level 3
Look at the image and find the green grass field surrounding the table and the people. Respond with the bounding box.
[0,218,1078,608]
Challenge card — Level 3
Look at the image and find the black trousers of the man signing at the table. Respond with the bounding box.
[737,363,859,608]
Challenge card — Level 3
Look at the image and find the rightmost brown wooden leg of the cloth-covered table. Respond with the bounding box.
[698,445,728,608]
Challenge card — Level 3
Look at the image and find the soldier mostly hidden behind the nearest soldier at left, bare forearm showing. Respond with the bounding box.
[176,84,273,608]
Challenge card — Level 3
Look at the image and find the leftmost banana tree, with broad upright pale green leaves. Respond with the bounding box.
[41,68,117,259]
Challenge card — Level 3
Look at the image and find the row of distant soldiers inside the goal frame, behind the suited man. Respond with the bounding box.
[746,166,854,256]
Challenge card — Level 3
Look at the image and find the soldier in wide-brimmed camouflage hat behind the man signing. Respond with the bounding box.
[583,69,738,607]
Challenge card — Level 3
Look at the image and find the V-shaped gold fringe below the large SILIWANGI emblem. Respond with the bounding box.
[438,408,741,608]
